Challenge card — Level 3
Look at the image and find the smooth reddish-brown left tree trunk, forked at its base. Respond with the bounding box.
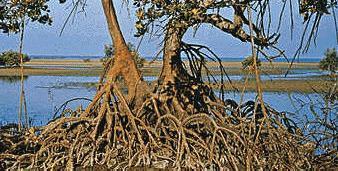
[102,0,147,103]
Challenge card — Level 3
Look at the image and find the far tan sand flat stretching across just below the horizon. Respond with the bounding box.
[0,59,318,76]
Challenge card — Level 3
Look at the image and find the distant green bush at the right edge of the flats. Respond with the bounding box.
[319,48,338,75]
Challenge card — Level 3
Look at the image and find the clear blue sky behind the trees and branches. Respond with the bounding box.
[0,0,338,58]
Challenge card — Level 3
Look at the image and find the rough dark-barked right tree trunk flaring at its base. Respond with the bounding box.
[154,27,214,119]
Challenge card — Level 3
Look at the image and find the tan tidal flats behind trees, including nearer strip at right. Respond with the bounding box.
[0,59,327,93]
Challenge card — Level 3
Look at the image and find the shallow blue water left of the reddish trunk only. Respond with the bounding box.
[0,76,98,125]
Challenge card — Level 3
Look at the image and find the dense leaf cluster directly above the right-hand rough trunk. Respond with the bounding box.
[134,0,219,36]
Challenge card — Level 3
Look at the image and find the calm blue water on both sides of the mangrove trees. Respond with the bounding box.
[0,76,320,125]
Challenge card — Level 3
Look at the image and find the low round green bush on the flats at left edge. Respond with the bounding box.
[0,50,30,67]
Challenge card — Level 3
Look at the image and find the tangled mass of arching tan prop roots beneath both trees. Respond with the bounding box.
[0,80,324,170]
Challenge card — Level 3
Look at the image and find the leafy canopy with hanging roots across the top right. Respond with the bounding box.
[134,0,337,46]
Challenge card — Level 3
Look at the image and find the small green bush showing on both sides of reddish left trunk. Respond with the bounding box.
[100,42,146,68]
